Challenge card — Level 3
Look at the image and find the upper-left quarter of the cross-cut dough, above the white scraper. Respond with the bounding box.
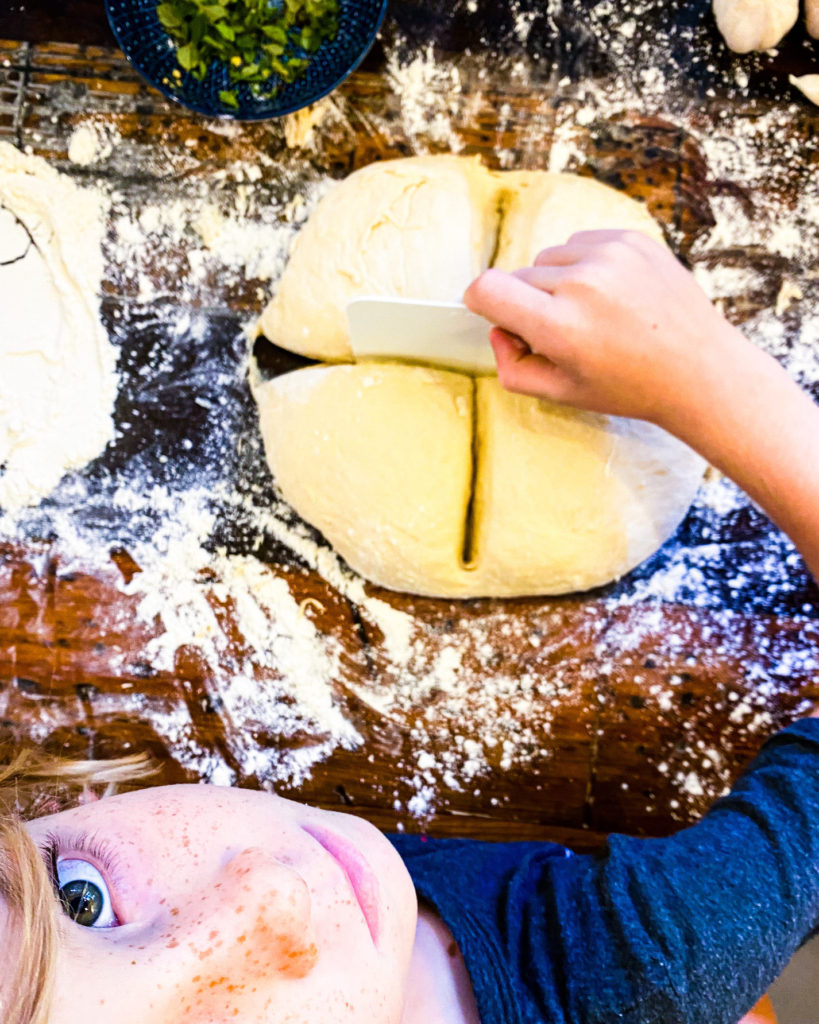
[259,157,498,360]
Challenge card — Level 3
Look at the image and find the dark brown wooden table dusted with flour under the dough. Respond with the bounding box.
[0,0,819,849]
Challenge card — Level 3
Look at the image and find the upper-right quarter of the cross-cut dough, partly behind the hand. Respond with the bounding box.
[493,171,664,270]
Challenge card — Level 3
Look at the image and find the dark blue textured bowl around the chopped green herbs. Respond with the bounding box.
[105,0,387,121]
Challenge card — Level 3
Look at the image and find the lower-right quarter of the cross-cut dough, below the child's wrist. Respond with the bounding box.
[466,377,704,596]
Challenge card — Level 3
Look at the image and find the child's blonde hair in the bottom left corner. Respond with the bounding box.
[0,750,158,1024]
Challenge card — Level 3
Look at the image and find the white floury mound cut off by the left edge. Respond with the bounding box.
[0,143,117,510]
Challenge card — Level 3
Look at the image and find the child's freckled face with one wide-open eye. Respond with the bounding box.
[16,785,417,1024]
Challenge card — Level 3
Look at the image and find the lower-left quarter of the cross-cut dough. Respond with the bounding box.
[255,362,473,594]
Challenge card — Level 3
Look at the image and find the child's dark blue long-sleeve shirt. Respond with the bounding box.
[390,719,819,1024]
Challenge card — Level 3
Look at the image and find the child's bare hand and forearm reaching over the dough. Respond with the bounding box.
[464,231,819,581]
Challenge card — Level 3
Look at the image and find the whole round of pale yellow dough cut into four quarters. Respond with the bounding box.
[253,157,704,598]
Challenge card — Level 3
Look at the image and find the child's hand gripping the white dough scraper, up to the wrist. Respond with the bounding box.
[464,231,748,429]
